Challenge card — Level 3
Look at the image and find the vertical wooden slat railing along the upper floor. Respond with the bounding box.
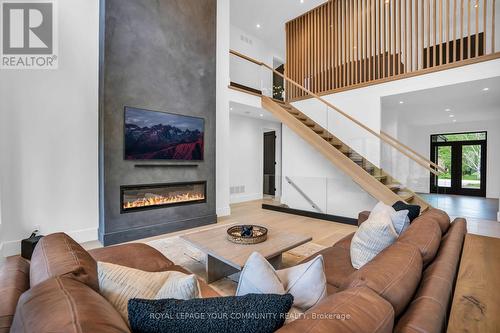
[285,0,500,100]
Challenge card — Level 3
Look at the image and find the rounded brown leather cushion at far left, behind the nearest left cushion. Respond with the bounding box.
[30,233,99,291]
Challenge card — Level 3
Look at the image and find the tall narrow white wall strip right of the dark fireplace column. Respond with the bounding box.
[215,0,231,216]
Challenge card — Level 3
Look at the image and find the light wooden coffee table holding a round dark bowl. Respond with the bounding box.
[181,223,312,283]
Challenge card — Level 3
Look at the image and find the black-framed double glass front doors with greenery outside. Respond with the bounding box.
[430,132,487,197]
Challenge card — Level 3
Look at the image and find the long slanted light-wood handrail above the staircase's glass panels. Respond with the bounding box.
[229,50,439,176]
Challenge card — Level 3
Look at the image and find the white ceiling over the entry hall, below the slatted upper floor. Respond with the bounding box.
[382,77,500,126]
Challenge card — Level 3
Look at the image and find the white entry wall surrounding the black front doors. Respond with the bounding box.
[392,119,500,198]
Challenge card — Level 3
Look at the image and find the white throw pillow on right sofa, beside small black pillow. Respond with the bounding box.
[351,212,398,269]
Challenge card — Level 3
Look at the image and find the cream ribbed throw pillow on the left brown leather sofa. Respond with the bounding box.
[97,262,200,322]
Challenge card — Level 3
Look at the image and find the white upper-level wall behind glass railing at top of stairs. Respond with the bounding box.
[230,25,284,96]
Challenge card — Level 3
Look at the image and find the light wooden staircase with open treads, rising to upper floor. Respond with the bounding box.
[262,96,430,212]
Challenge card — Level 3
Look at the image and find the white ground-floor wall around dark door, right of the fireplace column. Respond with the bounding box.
[230,114,281,203]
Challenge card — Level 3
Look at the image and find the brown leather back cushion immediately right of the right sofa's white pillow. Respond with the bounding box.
[398,217,441,267]
